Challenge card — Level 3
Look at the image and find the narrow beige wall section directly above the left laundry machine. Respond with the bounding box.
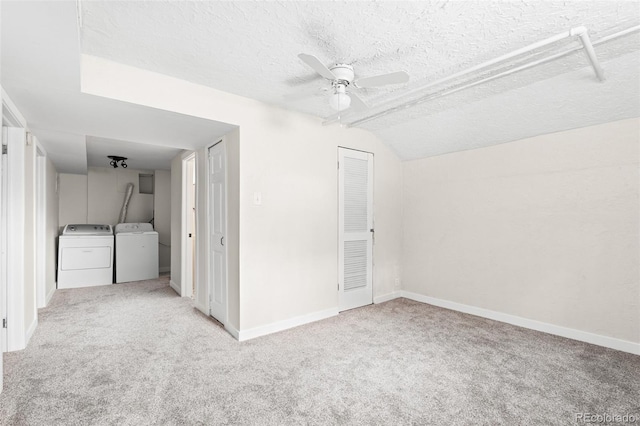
[58,173,88,227]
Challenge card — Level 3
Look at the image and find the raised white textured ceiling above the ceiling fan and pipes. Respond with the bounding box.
[81,1,640,159]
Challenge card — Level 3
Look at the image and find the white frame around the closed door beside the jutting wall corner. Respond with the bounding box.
[206,138,229,326]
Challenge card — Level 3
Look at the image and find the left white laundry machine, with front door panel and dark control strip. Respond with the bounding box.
[58,224,113,288]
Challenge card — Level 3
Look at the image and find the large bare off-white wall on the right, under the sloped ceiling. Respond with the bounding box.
[403,119,640,342]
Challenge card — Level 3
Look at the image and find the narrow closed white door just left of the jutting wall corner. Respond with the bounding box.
[209,142,227,324]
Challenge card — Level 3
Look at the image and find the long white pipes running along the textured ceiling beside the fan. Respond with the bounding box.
[322,25,640,127]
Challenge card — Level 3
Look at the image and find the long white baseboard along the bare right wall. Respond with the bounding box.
[400,291,640,355]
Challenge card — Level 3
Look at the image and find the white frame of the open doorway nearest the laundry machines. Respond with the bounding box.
[180,151,198,297]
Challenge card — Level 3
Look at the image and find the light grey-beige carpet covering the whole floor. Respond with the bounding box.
[0,277,640,425]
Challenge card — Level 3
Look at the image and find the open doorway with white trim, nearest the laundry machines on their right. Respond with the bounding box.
[182,152,197,298]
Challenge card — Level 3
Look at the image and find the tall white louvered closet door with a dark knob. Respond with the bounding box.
[338,148,373,311]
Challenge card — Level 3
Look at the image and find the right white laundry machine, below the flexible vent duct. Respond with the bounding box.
[115,223,159,283]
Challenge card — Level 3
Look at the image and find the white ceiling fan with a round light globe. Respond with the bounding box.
[298,53,409,112]
